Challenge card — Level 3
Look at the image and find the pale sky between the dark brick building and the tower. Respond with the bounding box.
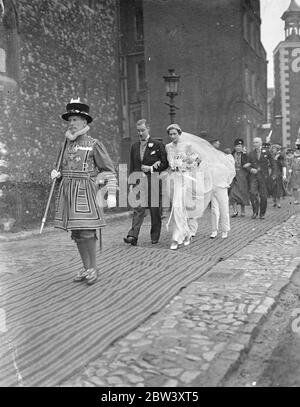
[260,0,300,88]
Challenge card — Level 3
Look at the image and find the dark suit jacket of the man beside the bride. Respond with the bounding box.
[129,137,169,174]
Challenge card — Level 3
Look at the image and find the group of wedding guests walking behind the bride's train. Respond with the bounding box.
[229,137,300,219]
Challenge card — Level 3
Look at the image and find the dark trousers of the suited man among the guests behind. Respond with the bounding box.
[250,175,268,215]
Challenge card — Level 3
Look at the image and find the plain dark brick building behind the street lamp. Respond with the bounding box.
[120,0,267,153]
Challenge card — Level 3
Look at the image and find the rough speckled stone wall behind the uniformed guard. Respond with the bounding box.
[0,0,120,227]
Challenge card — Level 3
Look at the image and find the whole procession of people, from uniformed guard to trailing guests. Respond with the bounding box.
[51,99,300,285]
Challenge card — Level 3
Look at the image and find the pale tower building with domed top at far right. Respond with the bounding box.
[272,0,300,147]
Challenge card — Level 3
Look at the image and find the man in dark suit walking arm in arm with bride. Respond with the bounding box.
[124,119,168,246]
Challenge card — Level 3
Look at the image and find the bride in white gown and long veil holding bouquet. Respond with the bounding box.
[166,123,235,250]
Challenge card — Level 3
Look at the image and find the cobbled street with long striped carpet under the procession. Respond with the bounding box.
[0,199,300,387]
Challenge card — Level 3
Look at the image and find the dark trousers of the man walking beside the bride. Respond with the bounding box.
[127,206,161,240]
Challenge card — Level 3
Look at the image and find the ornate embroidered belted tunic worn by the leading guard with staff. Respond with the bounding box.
[54,133,116,230]
